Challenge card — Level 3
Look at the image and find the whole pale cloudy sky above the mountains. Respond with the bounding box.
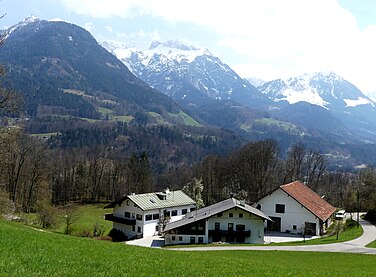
[0,0,376,93]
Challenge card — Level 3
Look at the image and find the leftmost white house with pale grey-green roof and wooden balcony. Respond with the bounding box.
[105,189,196,239]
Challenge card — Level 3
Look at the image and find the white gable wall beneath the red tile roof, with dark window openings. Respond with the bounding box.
[256,189,320,235]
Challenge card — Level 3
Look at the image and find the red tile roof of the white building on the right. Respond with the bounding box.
[280,181,336,221]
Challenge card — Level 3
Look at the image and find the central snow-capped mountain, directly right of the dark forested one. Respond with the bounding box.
[102,40,264,106]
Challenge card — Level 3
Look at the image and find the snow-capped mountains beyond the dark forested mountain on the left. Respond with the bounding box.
[102,41,376,142]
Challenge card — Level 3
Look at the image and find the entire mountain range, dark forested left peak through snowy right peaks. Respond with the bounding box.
[0,17,376,167]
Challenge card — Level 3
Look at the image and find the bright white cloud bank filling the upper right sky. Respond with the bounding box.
[61,0,376,91]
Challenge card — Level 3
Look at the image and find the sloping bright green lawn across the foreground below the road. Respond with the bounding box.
[0,220,376,276]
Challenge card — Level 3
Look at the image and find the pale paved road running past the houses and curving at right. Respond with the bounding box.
[170,219,376,255]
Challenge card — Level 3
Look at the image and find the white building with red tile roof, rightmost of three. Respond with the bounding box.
[255,181,336,235]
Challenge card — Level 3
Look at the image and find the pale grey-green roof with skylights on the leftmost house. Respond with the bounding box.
[105,190,196,211]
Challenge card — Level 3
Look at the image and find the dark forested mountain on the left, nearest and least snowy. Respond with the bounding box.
[0,17,188,124]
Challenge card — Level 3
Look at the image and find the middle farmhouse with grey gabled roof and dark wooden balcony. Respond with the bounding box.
[164,198,270,245]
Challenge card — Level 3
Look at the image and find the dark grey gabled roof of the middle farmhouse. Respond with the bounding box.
[164,198,272,231]
